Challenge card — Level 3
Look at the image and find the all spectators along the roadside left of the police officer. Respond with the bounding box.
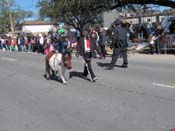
[0,27,106,58]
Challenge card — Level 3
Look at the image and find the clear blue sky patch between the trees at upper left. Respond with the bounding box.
[14,0,38,20]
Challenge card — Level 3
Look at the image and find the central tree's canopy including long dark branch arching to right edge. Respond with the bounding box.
[38,0,175,30]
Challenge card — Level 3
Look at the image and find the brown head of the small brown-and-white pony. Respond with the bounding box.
[62,50,72,69]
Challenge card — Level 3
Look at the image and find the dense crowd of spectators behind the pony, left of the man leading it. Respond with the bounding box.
[0,29,76,54]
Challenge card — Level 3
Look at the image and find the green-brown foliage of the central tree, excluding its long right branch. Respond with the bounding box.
[39,0,108,29]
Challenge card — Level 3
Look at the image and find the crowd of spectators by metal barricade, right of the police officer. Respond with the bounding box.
[128,18,175,54]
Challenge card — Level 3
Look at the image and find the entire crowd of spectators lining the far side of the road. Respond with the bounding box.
[0,16,175,55]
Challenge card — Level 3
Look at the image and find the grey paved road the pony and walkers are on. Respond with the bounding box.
[0,51,175,131]
